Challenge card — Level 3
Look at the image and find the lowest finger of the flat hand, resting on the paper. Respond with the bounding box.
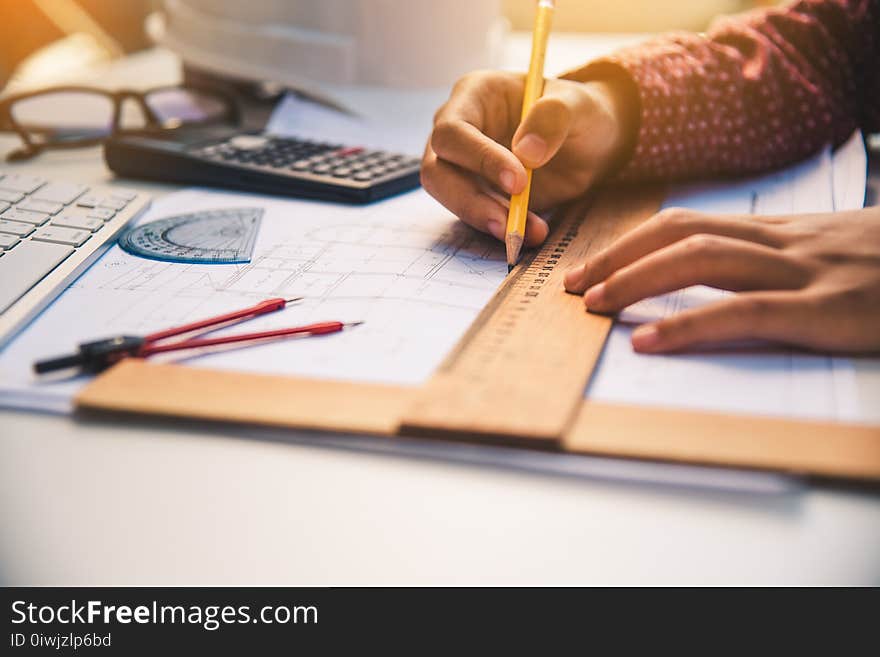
[632,291,809,353]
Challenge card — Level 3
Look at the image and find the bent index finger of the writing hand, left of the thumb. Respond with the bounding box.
[431,118,526,194]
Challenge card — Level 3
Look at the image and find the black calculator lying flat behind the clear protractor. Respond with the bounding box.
[104,128,420,203]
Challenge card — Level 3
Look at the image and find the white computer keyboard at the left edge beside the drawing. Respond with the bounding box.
[0,170,150,346]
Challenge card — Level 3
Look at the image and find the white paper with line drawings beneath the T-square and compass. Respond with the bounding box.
[0,135,865,421]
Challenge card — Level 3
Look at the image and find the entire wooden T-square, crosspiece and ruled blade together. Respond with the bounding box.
[76,181,880,482]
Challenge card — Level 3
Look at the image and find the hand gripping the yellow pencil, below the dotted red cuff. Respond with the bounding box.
[422,71,637,246]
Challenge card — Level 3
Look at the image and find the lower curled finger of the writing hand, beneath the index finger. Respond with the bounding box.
[421,153,507,241]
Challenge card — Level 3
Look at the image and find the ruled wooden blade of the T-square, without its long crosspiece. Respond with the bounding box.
[400,188,663,449]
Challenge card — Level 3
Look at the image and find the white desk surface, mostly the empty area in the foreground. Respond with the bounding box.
[0,47,880,585]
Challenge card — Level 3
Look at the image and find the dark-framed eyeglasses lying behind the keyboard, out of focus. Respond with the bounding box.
[0,85,240,162]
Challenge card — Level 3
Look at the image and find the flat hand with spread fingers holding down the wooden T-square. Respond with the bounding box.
[565,208,880,353]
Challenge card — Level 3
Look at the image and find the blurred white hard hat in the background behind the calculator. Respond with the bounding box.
[148,0,506,93]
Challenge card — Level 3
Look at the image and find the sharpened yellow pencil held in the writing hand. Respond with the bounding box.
[504,0,556,272]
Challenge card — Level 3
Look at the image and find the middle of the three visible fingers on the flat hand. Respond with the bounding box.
[584,235,809,312]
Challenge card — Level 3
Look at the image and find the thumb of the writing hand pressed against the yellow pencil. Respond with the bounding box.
[512,96,573,169]
